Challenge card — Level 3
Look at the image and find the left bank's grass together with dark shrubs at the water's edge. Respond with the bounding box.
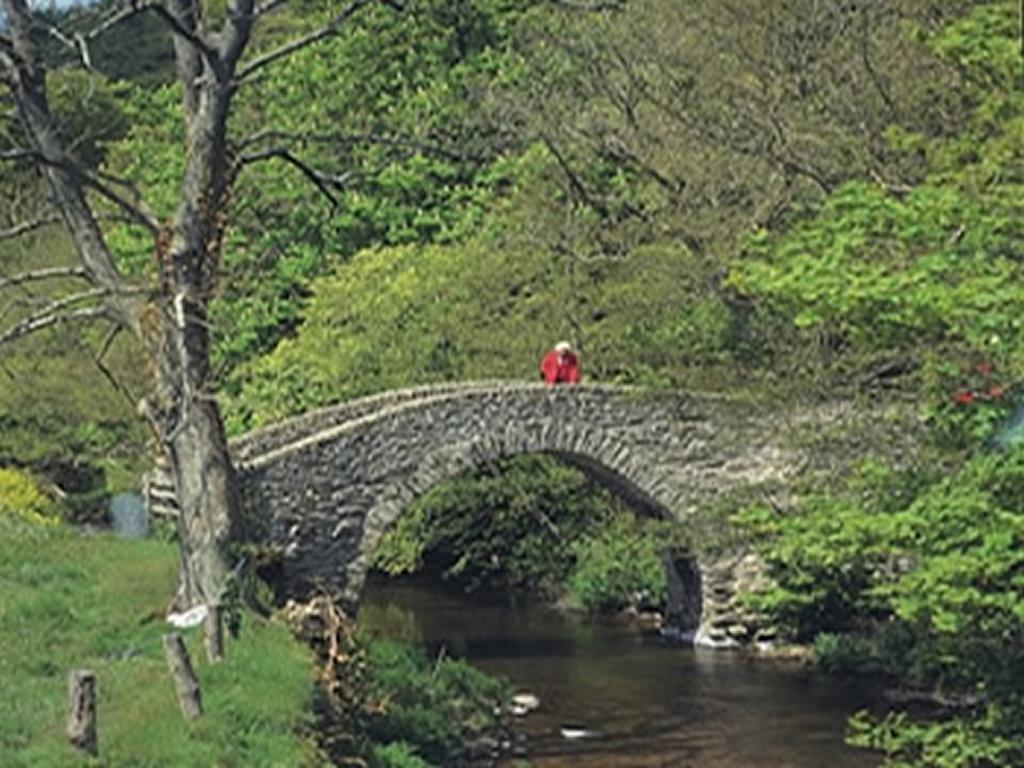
[0,489,509,768]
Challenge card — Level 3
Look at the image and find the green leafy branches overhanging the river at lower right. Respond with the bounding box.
[743,447,1024,766]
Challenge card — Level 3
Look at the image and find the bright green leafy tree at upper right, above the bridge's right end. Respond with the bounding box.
[729,3,1024,396]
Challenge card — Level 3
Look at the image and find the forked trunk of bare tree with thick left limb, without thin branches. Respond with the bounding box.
[0,0,242,607]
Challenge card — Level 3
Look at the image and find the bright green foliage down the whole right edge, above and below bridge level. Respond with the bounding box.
[731,3,1024,766]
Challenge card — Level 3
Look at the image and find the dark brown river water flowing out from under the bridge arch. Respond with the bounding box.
[359,578,879,768]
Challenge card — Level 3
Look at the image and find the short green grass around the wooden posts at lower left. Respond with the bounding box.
[0,517,325,768]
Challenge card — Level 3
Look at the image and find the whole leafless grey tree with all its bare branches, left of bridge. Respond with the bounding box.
[0,0,385,605]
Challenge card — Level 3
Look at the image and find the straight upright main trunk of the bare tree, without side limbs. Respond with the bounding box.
[155,24,248,607]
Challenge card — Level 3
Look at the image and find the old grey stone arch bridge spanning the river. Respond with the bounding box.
[153,382,905,643]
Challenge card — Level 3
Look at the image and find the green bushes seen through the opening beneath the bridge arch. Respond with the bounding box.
[374,456,671,611]
